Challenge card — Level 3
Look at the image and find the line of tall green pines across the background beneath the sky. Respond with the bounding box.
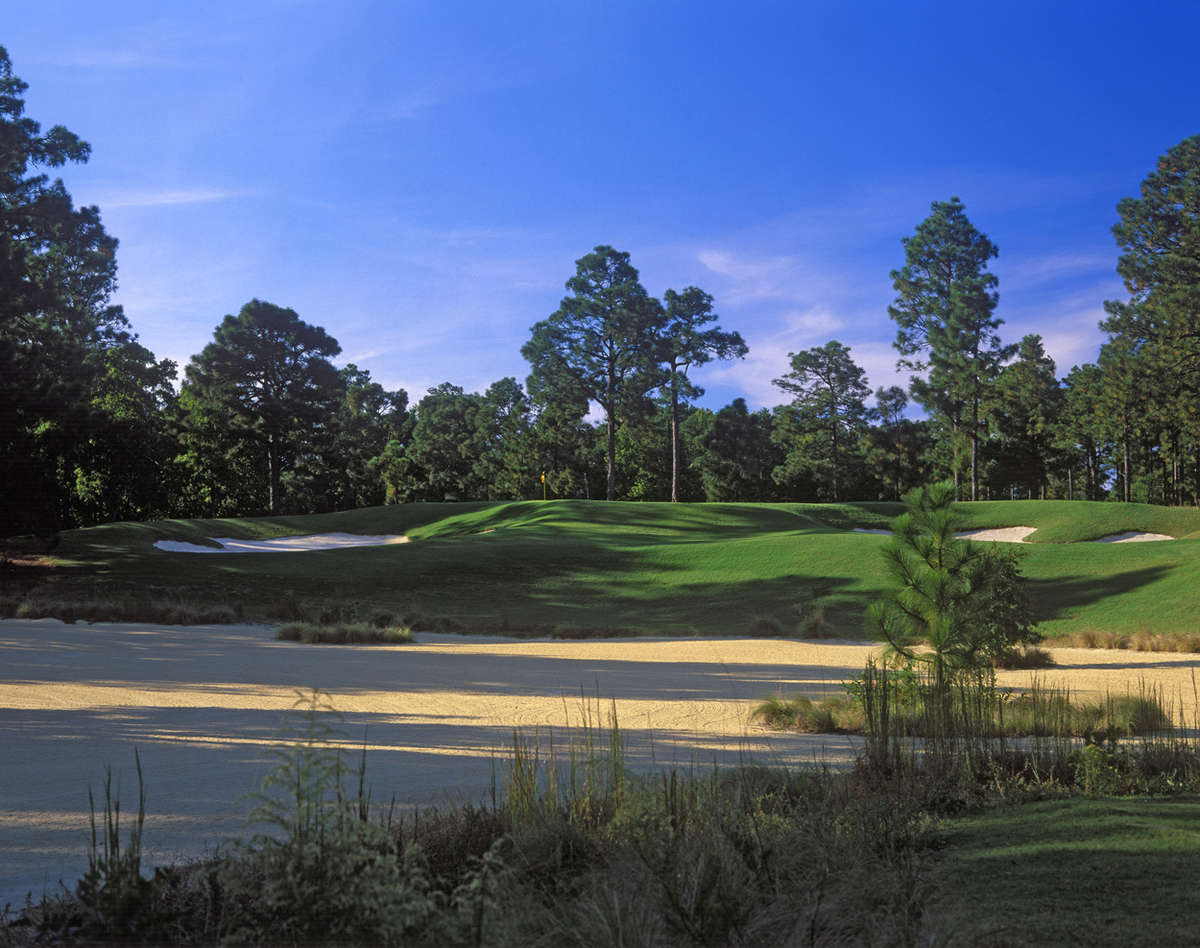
[0,48,1200,533]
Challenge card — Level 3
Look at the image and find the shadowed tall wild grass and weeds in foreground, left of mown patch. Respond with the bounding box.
[14,694,931,946]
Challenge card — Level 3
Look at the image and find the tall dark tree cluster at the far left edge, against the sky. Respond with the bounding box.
[0,47,174,533]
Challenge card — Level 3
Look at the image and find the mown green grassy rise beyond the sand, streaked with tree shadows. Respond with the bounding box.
[42,502,1200,635]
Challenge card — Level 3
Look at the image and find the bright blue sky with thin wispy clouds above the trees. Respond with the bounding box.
[9,0,1200,407]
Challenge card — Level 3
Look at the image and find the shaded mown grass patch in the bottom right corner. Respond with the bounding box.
[932,797,1200,946]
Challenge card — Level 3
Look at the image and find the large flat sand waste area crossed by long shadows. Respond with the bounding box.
[0,619,1198,906]
